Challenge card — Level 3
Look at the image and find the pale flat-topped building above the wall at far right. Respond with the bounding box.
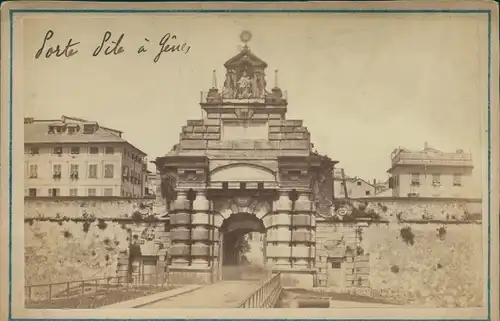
[387,144,473,198]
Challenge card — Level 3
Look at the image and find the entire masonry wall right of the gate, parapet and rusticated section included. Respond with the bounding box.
[316,199,484,307]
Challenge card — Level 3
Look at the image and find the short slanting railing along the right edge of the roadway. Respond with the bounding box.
[238,273,282,309]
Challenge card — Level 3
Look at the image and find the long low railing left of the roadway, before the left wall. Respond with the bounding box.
[25,272,170,309]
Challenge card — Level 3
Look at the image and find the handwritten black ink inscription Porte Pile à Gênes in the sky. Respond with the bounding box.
[35,30,191,63]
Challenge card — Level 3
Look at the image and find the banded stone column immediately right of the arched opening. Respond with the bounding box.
[266,190,292,267]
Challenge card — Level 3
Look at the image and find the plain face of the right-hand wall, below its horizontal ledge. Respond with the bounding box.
[360,223,484,307]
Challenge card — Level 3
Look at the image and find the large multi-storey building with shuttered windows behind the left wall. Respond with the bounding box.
[24,116,146,198]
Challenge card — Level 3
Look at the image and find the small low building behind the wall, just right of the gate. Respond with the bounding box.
[333,169,376,198]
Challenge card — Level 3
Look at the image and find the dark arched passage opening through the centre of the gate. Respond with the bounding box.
[220,213,266,280]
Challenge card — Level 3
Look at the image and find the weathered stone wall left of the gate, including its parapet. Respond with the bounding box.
[24,198,169,284]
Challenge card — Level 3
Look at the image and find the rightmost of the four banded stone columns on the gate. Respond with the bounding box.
[291,192,316,268]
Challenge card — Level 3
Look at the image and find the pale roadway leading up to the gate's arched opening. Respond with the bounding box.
[141,281,262,309]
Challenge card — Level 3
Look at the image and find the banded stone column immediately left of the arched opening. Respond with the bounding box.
[191,190,211,268]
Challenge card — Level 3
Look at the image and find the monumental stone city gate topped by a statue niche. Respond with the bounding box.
[155,32,335,286]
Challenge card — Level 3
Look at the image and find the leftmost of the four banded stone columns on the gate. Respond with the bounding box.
[170,191,191,266]
